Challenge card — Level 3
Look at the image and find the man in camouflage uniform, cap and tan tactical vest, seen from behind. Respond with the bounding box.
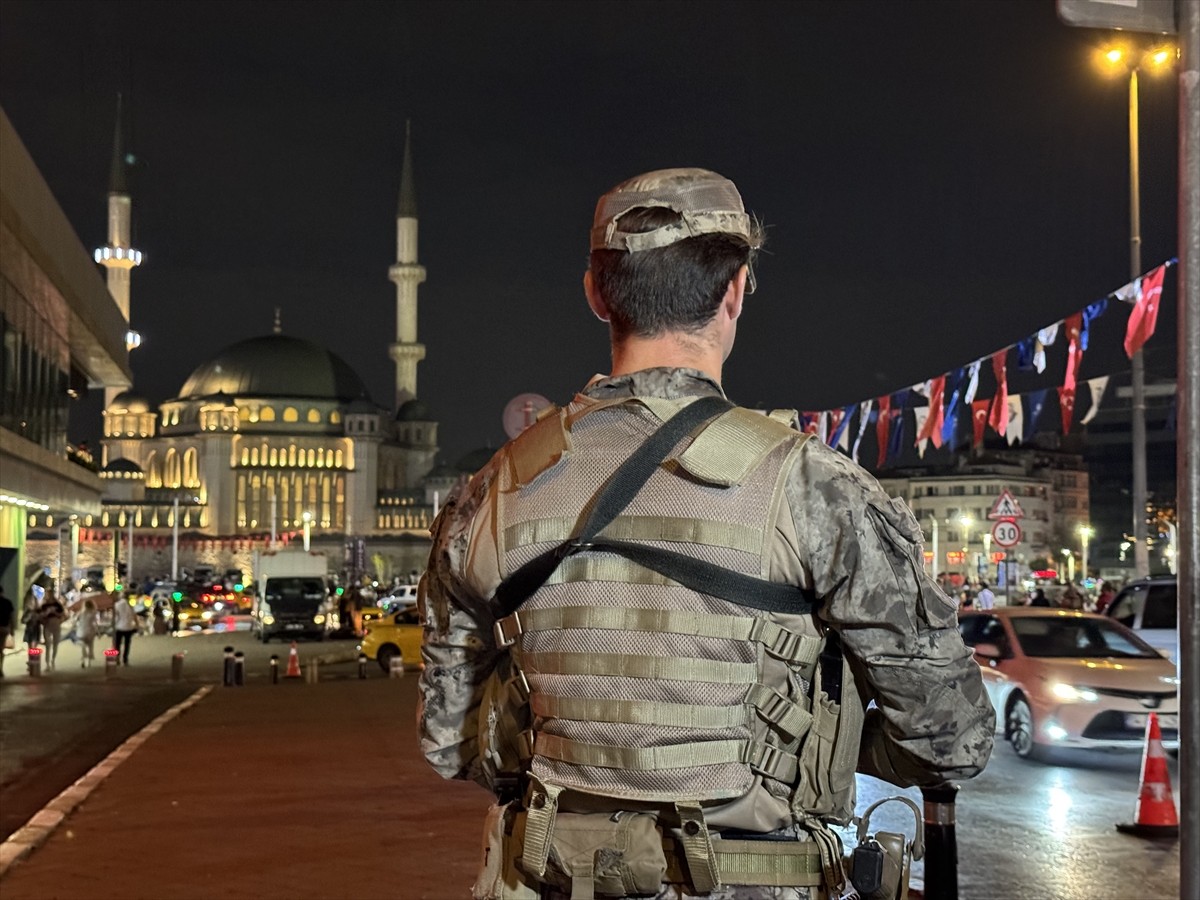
[420,169,995,900]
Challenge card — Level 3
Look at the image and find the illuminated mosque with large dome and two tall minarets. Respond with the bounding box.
[31,120,462,578]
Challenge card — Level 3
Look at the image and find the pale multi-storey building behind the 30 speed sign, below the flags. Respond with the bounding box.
[880,446,1090,582]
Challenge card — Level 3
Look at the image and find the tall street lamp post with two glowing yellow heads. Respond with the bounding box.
[1099,43,1177,578]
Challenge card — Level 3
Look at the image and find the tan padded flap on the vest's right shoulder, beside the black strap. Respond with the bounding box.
[678,407,808,487]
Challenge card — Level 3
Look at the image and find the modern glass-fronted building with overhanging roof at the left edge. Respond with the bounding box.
[0,110,131,604]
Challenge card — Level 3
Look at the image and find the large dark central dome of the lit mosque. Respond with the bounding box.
[179,335,367,403]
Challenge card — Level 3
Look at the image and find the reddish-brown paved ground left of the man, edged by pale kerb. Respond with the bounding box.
[0,673,490,900]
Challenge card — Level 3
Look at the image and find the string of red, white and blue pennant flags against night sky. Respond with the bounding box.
[800,259,1178,468]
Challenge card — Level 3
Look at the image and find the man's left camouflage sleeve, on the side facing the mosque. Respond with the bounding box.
[416,460,498,781]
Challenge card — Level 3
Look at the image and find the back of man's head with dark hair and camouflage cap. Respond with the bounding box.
[590,169,763,340]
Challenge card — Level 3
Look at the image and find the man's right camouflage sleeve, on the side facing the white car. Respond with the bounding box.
[786,440,996,786]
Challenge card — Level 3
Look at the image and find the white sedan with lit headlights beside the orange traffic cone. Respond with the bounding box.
[959,606,1180,760]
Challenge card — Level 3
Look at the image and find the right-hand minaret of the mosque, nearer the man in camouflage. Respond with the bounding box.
[388,122,425,409]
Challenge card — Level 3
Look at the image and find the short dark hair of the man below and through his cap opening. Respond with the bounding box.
[590,206,755,341]
